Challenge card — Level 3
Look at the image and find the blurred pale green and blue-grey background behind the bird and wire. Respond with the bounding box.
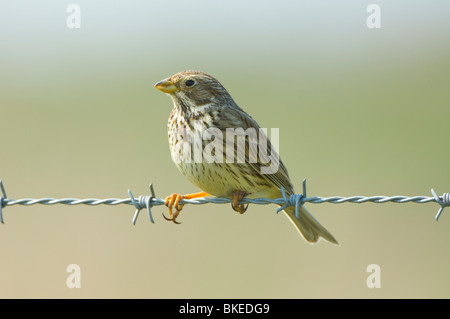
[0,0,450,298]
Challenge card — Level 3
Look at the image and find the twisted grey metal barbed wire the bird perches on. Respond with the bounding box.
[0,179,450,225]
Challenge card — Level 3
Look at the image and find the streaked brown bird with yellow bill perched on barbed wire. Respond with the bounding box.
[155,70,339,245]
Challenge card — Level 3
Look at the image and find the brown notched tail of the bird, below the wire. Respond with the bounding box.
[284,206,339,245]
